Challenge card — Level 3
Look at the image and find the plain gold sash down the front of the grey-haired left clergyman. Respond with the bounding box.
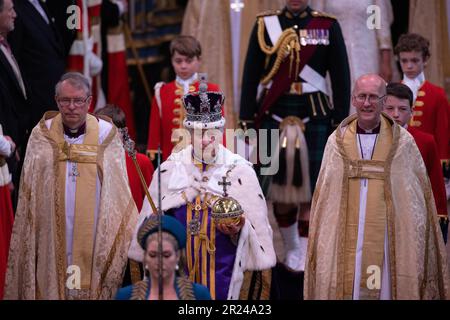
[49,114,99,290]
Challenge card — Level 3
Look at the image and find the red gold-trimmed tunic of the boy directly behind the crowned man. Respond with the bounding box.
[147,81,223,161]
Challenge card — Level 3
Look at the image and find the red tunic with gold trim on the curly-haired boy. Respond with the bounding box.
[409,81,450,162]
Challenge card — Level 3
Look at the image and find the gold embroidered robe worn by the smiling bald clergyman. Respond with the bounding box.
[304,115,449,299]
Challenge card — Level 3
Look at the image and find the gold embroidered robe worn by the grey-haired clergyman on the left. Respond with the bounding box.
[5,112,137,300]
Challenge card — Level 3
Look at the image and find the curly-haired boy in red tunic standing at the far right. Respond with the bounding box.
[395,33,450,185]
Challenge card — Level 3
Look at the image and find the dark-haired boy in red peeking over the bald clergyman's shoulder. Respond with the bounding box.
[384,83,448,242]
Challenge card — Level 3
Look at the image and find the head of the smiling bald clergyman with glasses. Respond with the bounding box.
[352,74,386,130]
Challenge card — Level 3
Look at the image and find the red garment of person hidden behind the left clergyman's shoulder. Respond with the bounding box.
[126,153,154,212]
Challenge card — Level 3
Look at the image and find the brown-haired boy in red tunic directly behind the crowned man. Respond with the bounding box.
[147,36,220,161]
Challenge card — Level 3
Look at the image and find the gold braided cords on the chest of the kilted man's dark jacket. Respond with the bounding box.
[258,17,300,85]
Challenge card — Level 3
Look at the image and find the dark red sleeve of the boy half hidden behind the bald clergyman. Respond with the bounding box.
[425,136,447,215]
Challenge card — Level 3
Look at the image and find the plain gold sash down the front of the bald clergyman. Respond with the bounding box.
[343,118,392,299]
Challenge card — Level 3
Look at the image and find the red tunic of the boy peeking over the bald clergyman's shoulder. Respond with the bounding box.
[408,127,447,216]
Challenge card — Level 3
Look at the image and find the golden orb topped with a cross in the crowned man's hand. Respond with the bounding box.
[211,177,244,225]
